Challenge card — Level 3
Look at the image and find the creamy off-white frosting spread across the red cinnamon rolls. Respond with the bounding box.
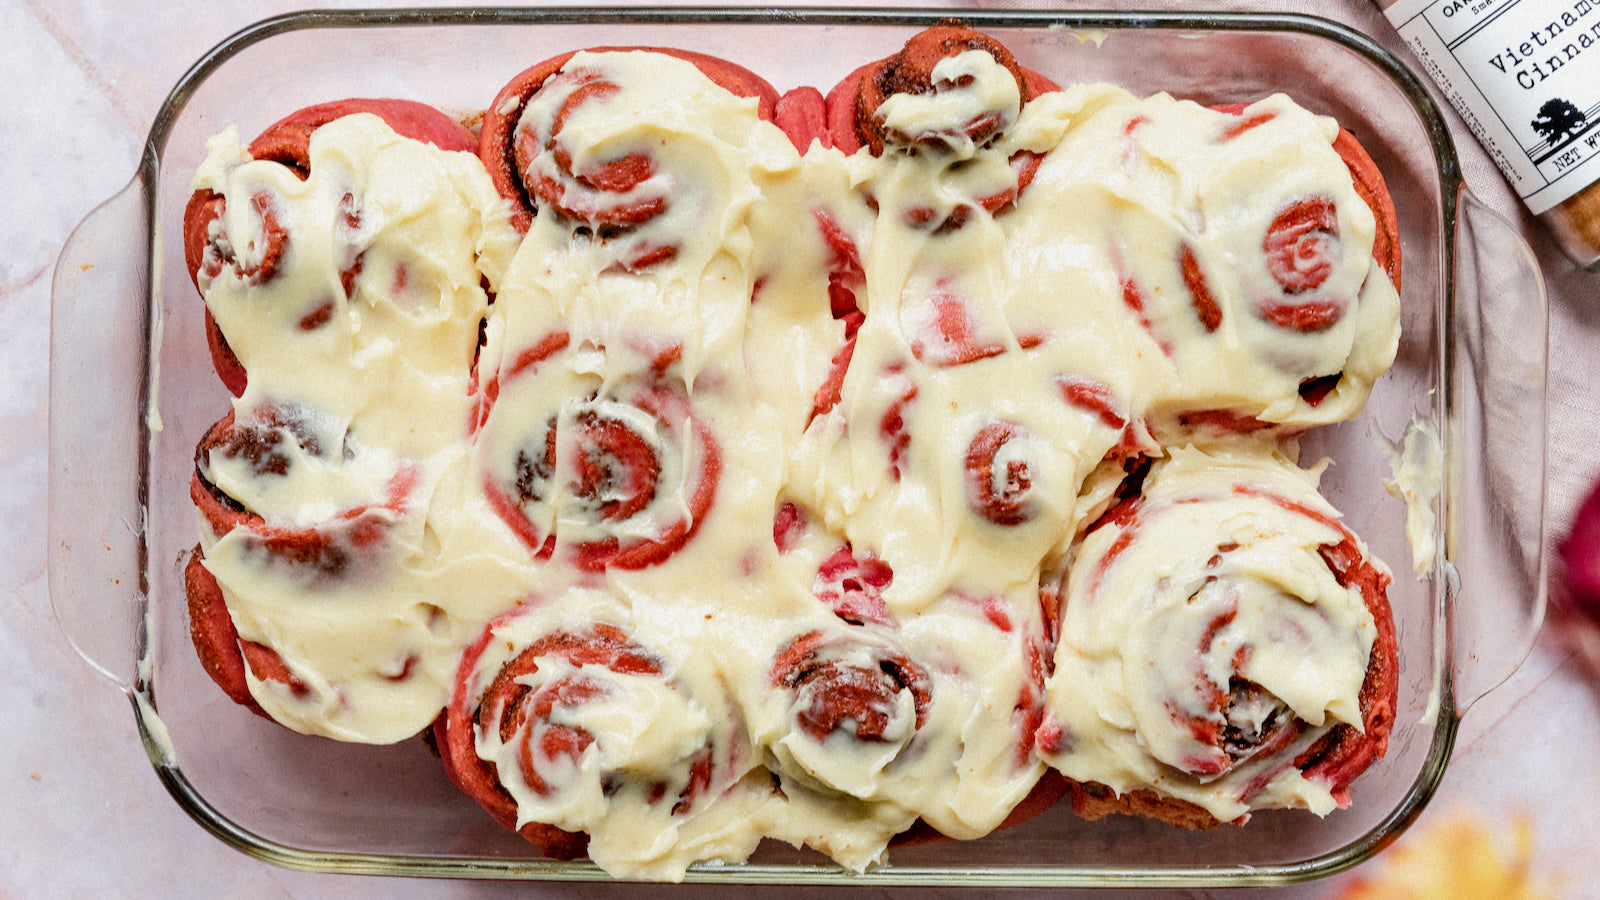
[195,43,1397,878]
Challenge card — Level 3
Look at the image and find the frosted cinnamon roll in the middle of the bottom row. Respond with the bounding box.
[747,586,1062,845]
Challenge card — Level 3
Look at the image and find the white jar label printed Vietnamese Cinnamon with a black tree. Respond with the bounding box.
[1384,0,1600,215]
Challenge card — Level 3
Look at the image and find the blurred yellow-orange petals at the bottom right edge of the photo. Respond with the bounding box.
[1331,810,1557,900]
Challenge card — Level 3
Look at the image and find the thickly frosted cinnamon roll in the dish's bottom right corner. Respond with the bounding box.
[1037,448,1398,826]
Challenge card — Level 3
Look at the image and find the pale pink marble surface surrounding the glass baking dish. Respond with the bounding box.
[12,0,1600,898]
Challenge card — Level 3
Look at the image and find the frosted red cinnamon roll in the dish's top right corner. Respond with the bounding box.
[1082,94,1400,444]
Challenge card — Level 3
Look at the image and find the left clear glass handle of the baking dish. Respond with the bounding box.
[48,171,150,690]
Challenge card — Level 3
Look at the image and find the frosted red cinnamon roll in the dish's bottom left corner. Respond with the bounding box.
[184,405,491,743]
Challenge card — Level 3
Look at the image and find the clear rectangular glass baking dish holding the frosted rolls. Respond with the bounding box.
[50,8,1546,887]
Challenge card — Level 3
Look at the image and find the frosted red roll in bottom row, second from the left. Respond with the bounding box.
[434,591,774,878]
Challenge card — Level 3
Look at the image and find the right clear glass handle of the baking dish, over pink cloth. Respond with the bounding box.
[1445,189,1549,716]
